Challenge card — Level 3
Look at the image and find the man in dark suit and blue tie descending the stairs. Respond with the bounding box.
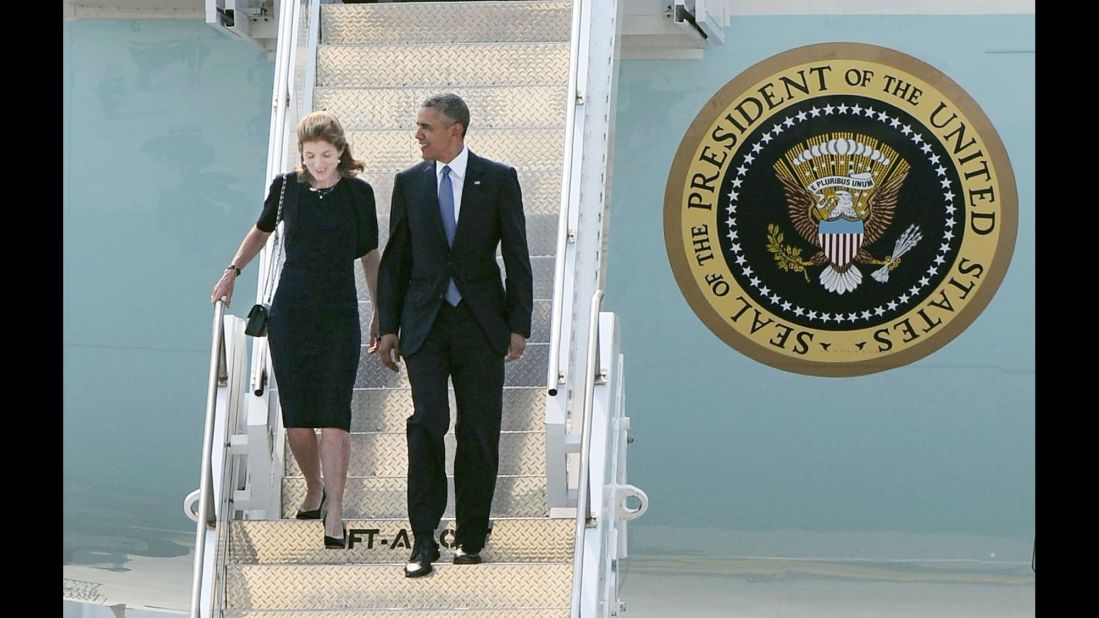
[378,95,534,577]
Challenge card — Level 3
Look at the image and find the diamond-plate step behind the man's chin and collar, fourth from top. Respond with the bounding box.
[347,126,565,171]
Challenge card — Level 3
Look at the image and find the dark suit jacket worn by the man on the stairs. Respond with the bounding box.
[378,151,534,356]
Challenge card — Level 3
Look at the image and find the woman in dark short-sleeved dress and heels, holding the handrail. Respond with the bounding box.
[211,111,379,549]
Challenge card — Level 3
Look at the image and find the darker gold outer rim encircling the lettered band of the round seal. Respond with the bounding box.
[664,43,1019,377]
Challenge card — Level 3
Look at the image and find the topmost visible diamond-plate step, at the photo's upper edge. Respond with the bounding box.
[321,2,573,45]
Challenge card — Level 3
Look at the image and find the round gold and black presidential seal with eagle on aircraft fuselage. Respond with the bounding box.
[664,43,1018,376]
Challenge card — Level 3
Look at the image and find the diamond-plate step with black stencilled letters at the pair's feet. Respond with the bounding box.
[229,518,576,564]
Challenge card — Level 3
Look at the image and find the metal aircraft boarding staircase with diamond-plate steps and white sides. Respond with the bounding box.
[192,0,645,618]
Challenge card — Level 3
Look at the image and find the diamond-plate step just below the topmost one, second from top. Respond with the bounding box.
[317,42,568,89]
